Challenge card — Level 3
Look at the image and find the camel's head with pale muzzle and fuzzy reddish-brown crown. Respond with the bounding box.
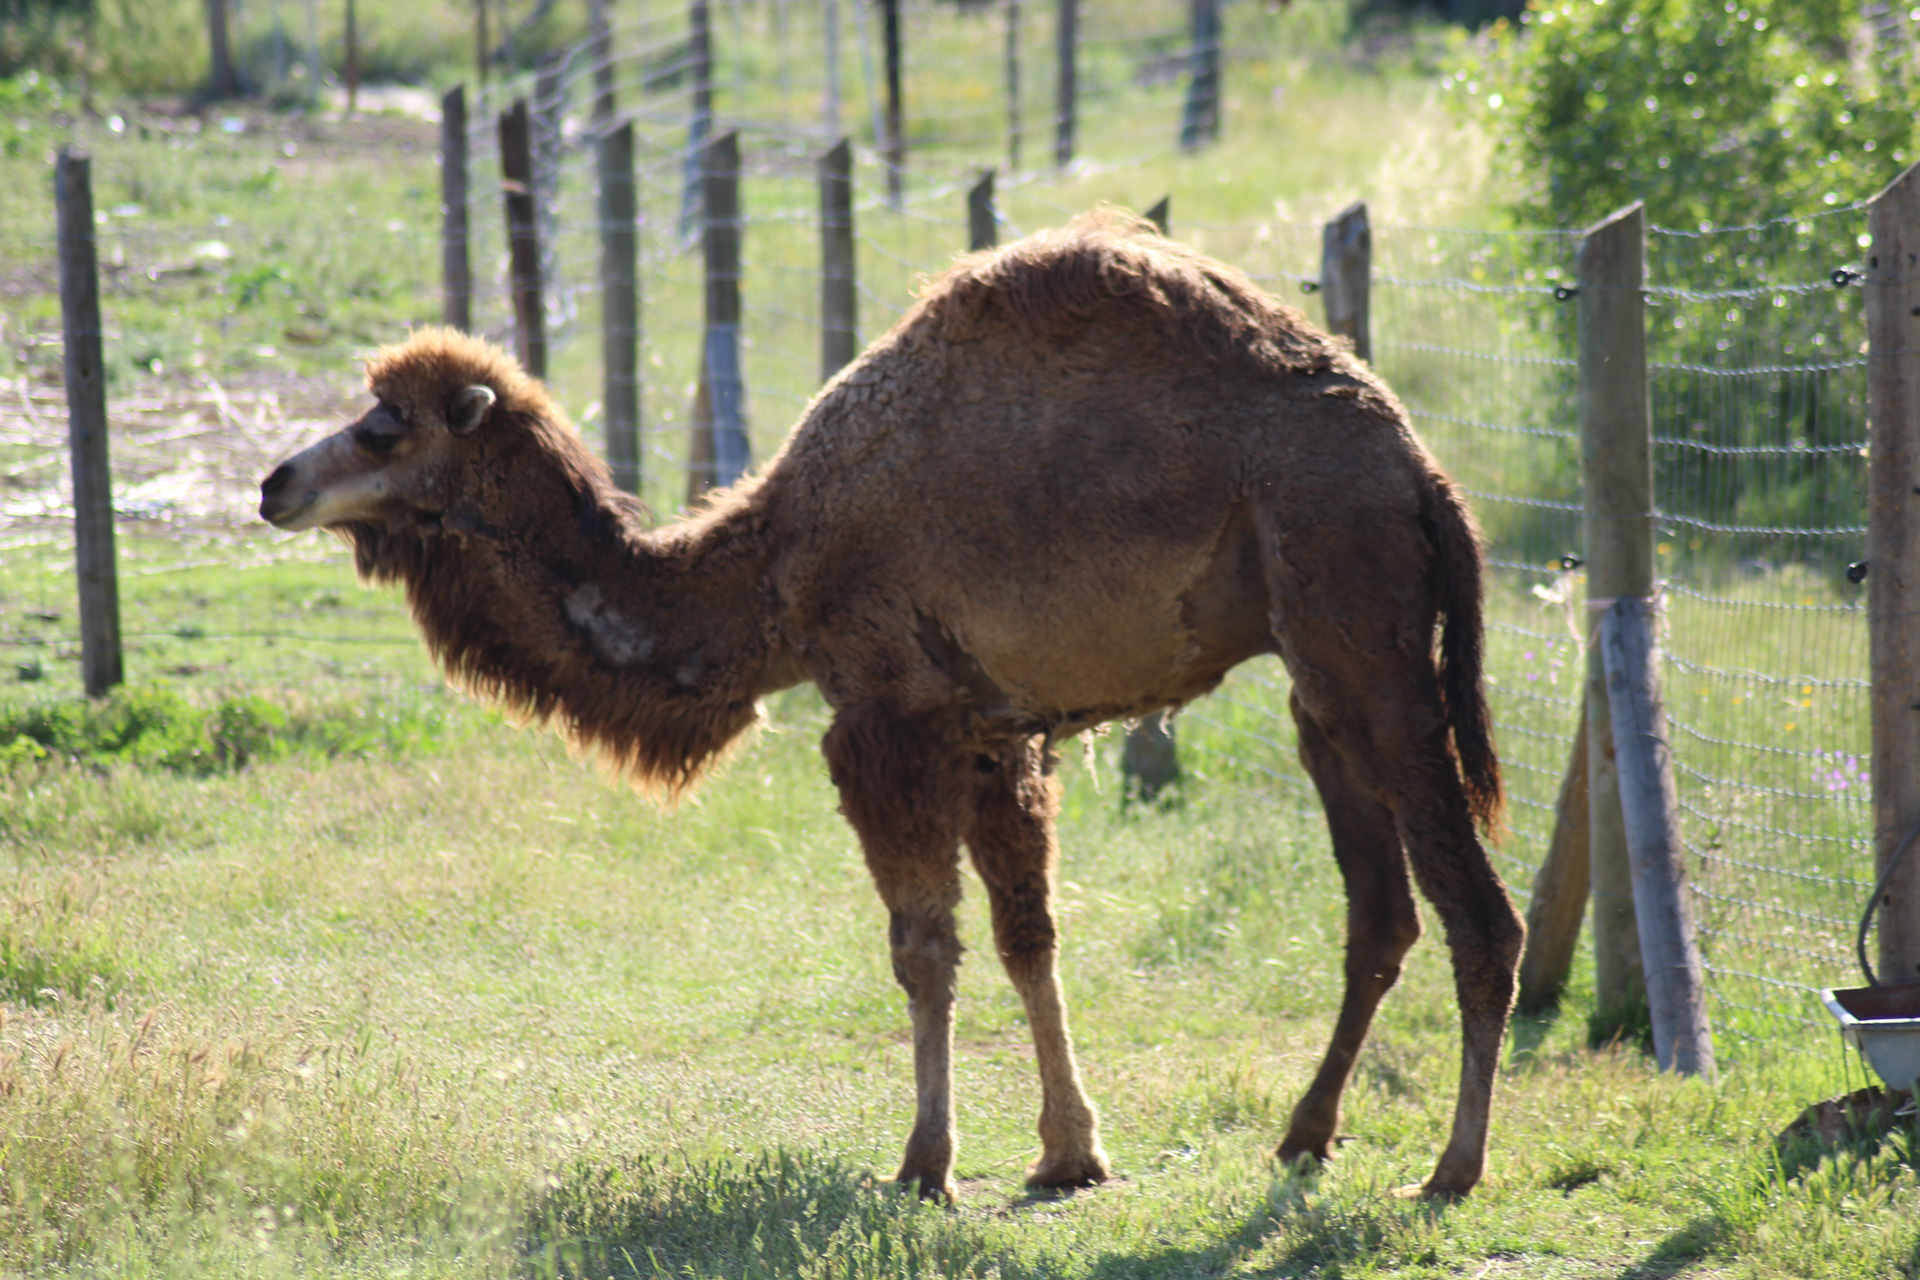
[259,328,551,532]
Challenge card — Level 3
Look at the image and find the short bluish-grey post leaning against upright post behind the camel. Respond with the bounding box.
[1599,595,1713,1077]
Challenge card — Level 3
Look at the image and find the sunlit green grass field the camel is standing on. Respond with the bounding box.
[0,0,1920,1280]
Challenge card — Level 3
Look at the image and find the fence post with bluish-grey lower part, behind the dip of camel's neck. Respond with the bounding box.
[687,132,753,501]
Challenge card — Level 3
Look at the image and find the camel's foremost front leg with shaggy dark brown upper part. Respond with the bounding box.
[824,706,972,1199]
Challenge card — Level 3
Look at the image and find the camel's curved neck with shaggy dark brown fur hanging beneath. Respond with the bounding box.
[344,397,770,794]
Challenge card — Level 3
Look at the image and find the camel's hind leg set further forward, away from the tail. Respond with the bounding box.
[1277,697,1421,1165]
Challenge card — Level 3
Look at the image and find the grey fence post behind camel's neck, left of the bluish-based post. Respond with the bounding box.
[597,121,639,493]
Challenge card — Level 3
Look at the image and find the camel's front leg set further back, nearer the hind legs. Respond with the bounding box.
[966,743,1108,1186]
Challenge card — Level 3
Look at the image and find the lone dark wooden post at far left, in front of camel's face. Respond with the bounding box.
[54,148,125,699]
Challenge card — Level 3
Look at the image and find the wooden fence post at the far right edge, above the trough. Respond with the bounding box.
[1866,165,1920,981]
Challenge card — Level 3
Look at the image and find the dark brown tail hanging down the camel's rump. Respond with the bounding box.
[1421,476,1505,835]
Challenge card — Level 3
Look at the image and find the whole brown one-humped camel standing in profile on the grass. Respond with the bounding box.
[261,213,1523,1196]
